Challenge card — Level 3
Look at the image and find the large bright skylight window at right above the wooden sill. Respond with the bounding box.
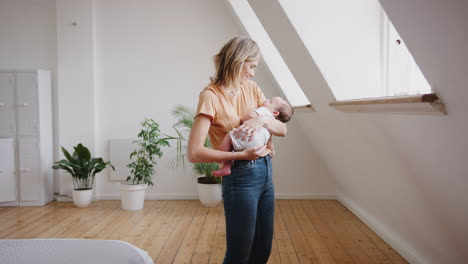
[278,0,431,100]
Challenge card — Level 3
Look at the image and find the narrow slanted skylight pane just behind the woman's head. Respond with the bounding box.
[229,0,310,107]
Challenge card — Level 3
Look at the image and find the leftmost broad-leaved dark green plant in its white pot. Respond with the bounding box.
[52,143,115,207]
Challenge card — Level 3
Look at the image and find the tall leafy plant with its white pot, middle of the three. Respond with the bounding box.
[120,119,179,211]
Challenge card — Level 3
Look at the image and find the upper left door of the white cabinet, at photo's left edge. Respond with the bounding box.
[0,72,16,138]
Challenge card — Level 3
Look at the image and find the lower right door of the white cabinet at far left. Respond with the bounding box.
[18,137,41,201]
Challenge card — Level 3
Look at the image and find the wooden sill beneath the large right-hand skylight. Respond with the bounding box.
[329,94,447,115]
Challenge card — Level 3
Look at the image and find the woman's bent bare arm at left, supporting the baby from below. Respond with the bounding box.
[187,115,266,163]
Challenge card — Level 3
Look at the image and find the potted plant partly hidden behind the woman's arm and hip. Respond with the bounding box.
[172,106,222,207]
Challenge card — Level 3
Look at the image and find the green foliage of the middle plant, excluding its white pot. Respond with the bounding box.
[127,118,181,185]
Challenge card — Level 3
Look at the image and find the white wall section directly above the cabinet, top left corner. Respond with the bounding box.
[0,0,57,71]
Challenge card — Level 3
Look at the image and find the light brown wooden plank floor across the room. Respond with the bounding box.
[0,200,408,264]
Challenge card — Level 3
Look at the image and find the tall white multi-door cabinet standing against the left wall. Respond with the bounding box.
[0,70,53,206]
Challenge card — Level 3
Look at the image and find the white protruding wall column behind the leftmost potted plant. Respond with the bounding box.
[56,0,95,195]
